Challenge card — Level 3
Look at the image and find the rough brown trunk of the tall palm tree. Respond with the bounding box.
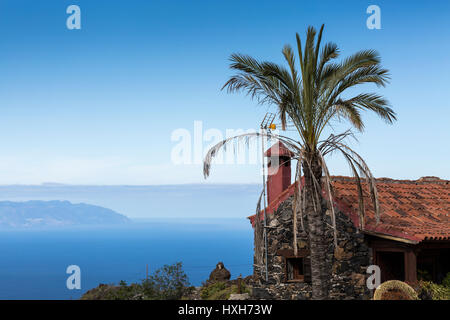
[303,153,330,300]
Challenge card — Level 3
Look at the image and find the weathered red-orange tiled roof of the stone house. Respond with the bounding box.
[249,177,450,243]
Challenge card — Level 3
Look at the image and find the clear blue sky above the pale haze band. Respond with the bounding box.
[0,0,450,184]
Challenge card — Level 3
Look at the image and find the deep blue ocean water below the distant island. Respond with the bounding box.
[0,217,253,300]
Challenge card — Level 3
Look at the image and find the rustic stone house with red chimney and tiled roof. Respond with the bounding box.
[249,143,450,299]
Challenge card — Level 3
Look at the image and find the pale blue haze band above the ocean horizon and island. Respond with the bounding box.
[0,184,261,218]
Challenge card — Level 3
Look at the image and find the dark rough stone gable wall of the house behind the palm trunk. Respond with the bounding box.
[253,197,372,300]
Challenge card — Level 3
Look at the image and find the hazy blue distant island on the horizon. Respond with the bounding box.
[0,200,130,228]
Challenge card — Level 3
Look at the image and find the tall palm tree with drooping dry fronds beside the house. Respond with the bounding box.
[203,25,396,299]
